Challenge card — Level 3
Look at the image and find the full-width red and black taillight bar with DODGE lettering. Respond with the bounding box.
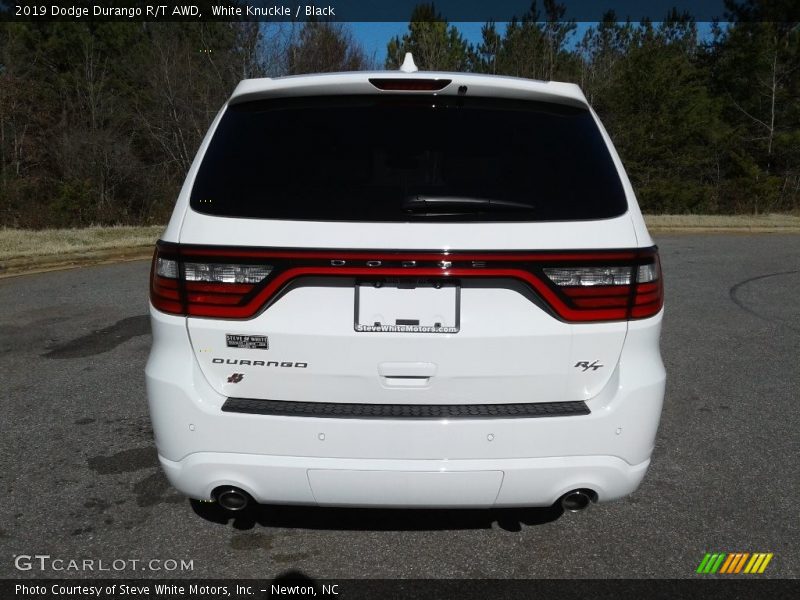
[150,242,663,323]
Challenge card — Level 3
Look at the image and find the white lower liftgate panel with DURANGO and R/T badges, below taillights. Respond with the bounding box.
[188,287,627,404]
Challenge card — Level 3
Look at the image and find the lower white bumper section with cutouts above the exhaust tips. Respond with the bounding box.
[160,452,650,508]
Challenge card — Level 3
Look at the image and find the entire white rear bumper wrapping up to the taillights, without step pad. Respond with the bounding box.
[146,304,665,507]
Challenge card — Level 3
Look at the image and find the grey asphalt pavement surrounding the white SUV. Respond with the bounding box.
[0,234,800,578]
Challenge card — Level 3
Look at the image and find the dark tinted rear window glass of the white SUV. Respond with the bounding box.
[191,95,627,222]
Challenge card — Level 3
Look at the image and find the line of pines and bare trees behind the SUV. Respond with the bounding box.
[0,0,800,228]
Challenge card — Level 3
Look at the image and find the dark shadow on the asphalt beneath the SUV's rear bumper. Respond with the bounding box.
[189,500,564,531]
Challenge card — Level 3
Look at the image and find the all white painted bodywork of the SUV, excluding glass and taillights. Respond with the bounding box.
[146,73,665,507]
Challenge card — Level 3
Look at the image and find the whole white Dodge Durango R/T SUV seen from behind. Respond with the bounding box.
[147,56,665,510]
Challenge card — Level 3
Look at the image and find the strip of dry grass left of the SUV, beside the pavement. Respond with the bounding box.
[0,225,164,260]
